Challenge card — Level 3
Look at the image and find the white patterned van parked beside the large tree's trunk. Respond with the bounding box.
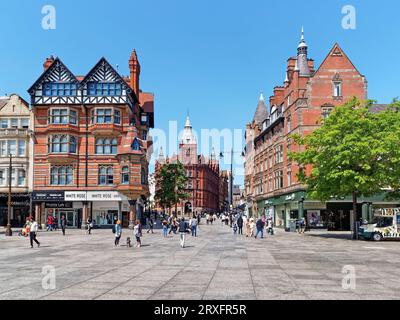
[358,208,400,241]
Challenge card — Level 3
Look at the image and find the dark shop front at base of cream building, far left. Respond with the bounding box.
[0,193,31,228]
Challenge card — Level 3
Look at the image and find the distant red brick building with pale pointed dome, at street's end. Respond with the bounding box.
[156,117,228,215]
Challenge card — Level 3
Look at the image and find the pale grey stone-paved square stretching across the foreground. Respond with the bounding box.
[0,221,400,300]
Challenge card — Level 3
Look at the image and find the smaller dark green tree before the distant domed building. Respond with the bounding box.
[155,161,188,215]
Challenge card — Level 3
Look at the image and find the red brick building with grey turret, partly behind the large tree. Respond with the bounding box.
[246,29,376,228]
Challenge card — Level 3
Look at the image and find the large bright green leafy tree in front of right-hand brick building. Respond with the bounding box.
[289,98,400,238]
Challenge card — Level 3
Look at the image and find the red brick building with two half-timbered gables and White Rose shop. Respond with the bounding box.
[29,51,154,227]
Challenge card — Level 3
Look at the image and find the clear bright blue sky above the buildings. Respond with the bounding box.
[0,0,400,183]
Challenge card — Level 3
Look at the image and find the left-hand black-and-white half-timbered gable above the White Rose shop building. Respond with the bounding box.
[28,58,82,105]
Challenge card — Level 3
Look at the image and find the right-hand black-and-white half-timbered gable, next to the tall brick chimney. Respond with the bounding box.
[81,58,137,111]
